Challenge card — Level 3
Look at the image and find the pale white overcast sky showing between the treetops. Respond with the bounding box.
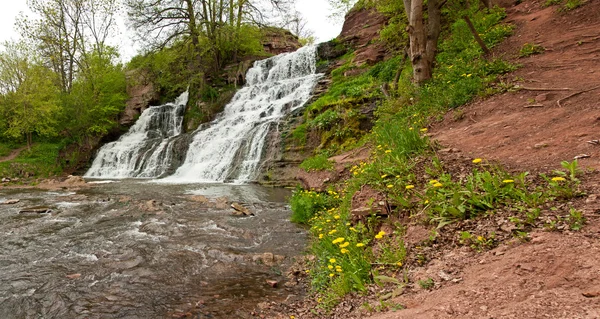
[0,0,342,60]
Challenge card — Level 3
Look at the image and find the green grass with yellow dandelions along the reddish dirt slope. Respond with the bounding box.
[291,3,581,309]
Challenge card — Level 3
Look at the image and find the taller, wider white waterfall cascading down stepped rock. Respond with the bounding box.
[161,46,322,183]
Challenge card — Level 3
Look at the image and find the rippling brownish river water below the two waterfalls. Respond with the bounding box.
[0,181,306,319]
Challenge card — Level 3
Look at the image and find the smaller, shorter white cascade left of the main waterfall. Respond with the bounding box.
[85,92,188,178]
